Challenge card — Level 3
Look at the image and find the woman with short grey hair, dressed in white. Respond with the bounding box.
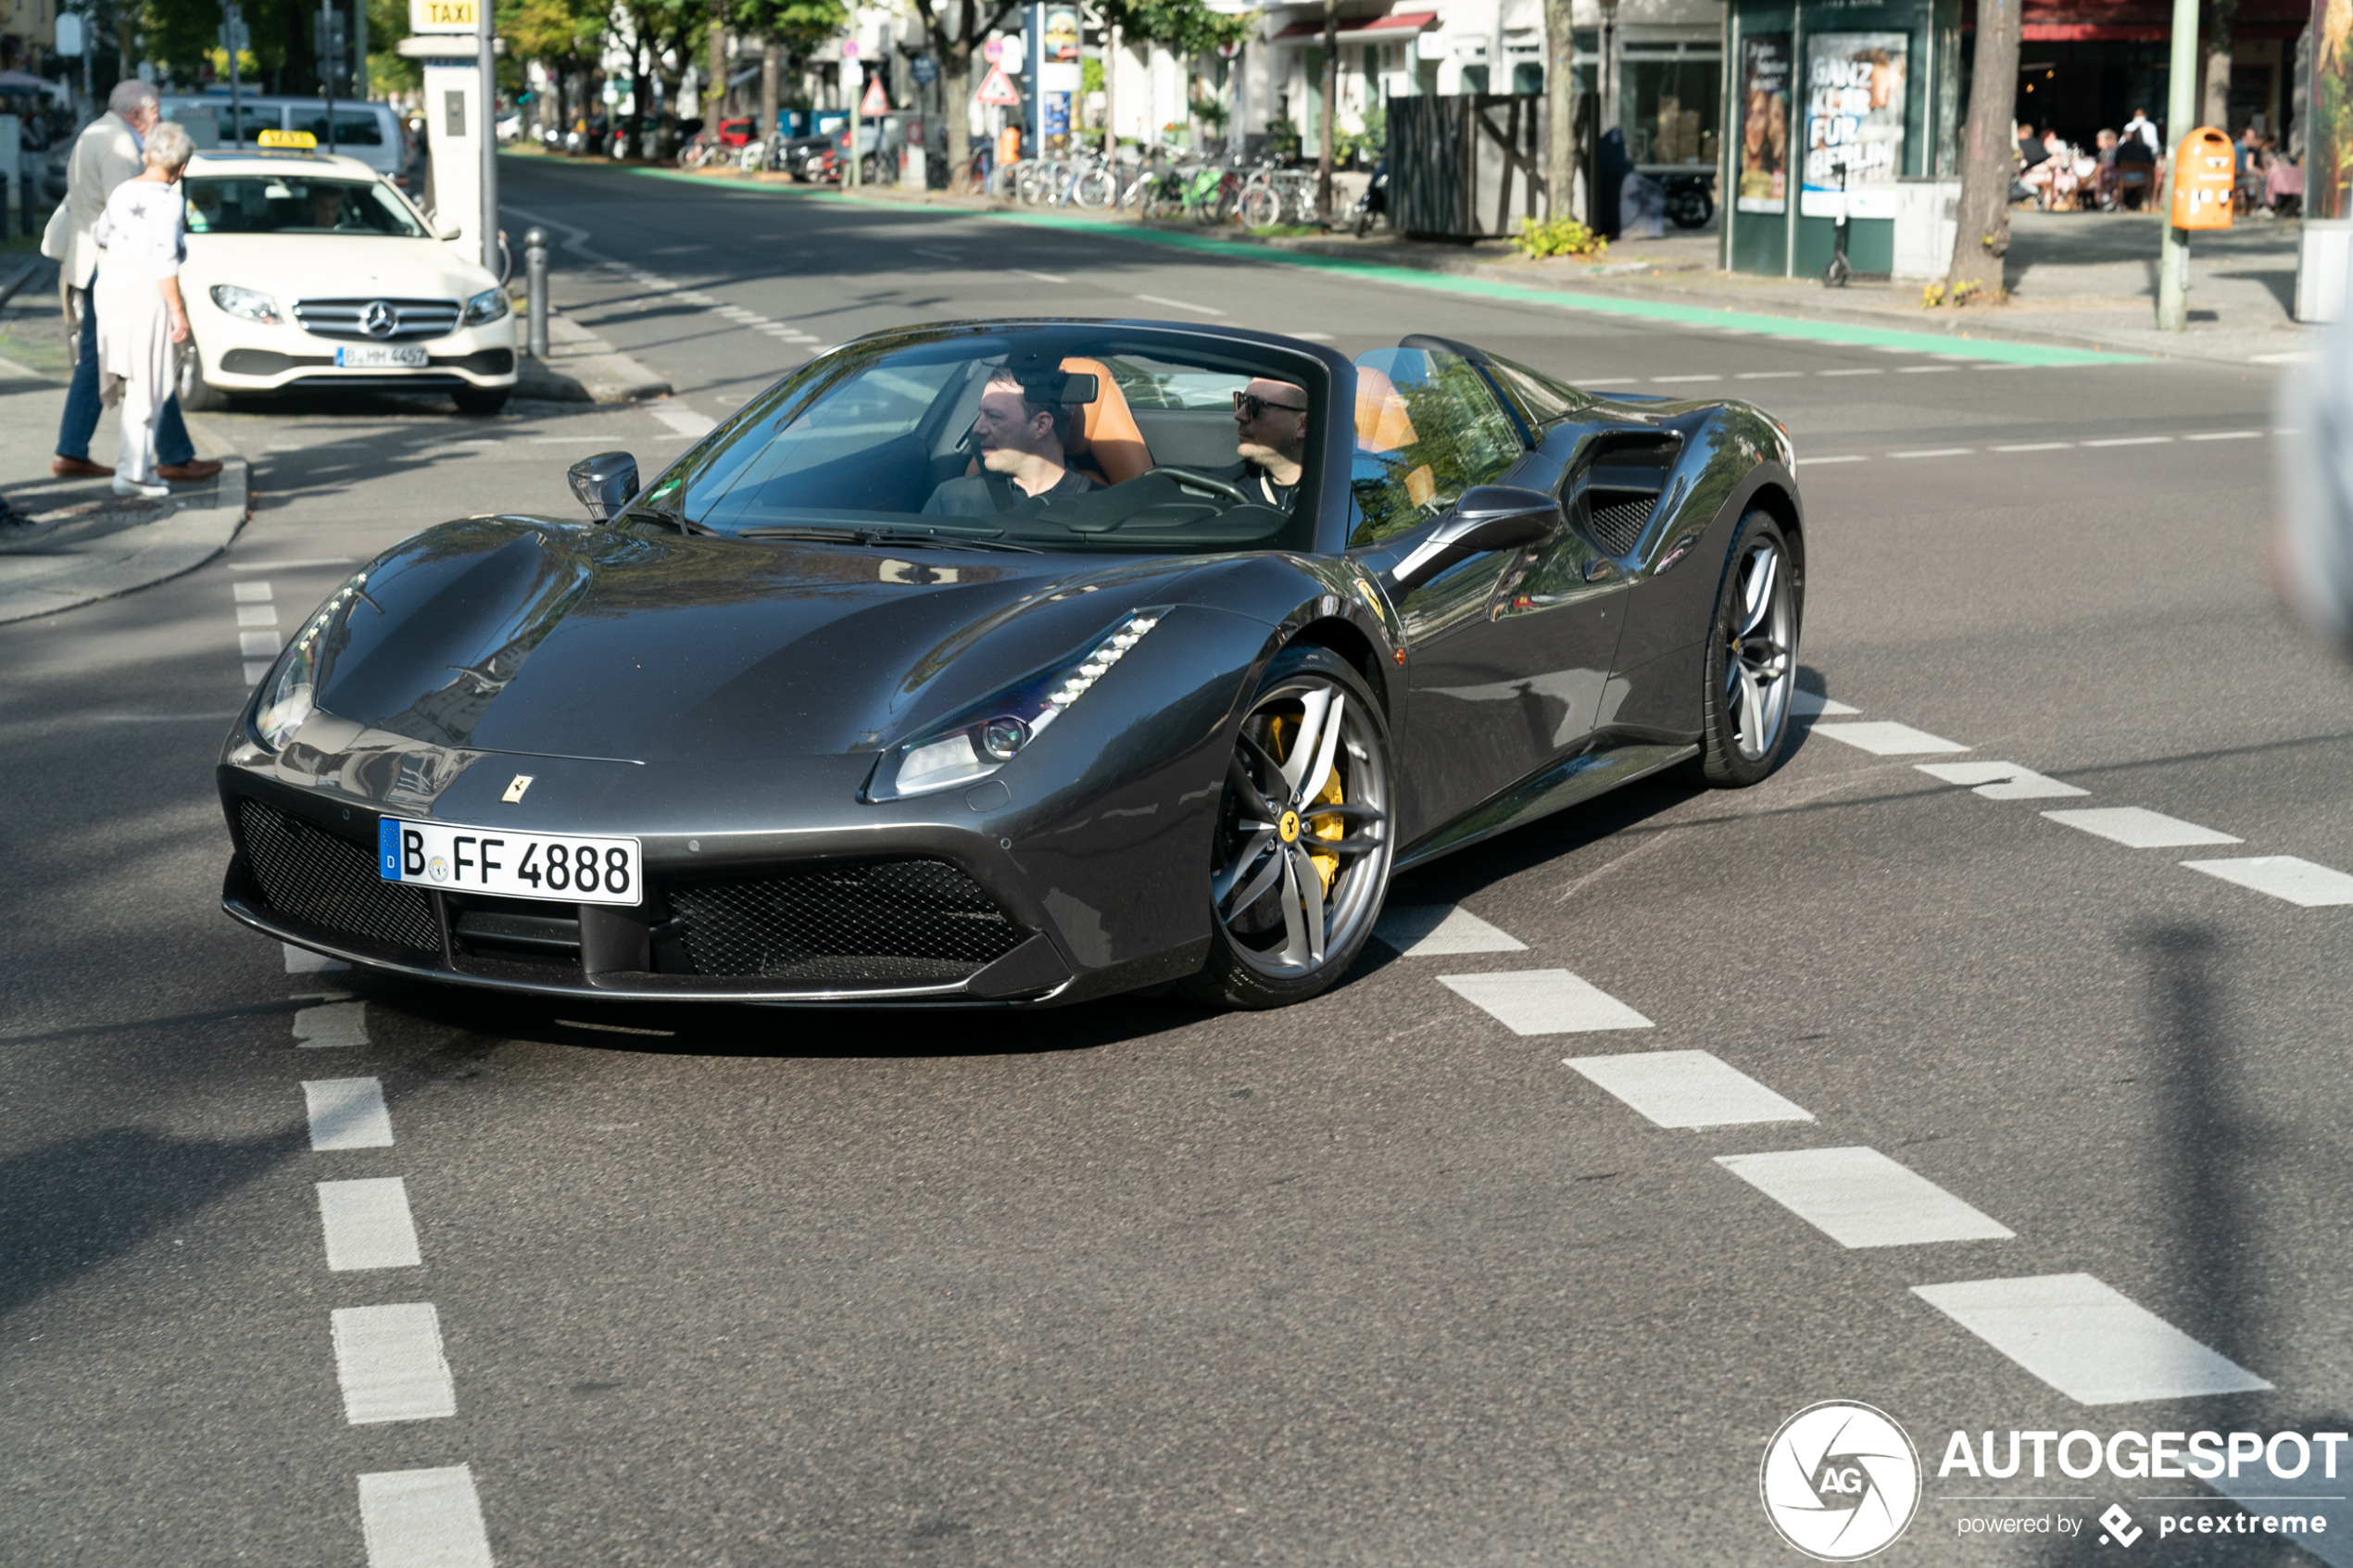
[94,119,195,496]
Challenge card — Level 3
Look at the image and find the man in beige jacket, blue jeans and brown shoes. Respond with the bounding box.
[40,82,221,484]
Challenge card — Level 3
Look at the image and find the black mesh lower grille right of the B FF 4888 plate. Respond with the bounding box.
[671,860,1024,985]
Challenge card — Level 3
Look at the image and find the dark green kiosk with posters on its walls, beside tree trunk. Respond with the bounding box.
[1722,0,1960,278]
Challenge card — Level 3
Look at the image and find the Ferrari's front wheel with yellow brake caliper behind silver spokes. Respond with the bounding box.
[1181,646,1395,1009]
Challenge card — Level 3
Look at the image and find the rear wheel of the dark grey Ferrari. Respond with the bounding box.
[1692,510,1803,790]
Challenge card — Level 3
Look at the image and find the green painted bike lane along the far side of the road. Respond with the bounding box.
[611,169,2151,367]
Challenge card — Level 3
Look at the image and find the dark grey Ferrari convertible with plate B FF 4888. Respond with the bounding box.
[219,320,1805,1006]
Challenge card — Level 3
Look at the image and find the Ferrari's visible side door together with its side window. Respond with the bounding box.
[1351,348,1617,842]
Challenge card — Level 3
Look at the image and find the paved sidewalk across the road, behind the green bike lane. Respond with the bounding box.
[631,167,2320,364]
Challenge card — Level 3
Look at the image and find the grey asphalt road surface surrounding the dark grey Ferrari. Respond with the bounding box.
[0,160,2353,1568]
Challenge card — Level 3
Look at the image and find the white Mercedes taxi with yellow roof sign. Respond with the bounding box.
[179,132,518,414]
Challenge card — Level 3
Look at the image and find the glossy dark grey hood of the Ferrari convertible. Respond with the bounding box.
[303,517,1242,761]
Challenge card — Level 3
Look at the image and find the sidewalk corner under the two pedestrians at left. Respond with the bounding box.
[0,263,252,623]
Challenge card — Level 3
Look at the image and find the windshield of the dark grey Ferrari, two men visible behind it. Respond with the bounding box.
[631,324,1325,552]
